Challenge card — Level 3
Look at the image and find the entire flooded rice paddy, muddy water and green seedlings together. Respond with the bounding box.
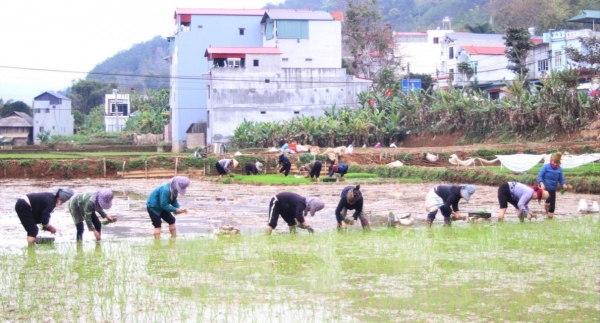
[0,179,600,322]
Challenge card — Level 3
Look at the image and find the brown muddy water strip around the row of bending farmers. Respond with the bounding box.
[0,179,598,246]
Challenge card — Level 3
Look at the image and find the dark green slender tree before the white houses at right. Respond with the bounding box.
[502,27,535,82]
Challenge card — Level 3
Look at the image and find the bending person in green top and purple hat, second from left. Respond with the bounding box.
[69,188,116,241]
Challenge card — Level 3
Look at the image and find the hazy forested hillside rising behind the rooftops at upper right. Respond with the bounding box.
[266,0,600,33]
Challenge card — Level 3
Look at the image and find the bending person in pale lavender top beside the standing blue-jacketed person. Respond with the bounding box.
[498,182,549,222]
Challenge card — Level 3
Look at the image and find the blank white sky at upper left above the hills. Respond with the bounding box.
[0,0,283,106]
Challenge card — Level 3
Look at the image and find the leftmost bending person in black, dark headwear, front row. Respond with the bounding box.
[15,188,73,246]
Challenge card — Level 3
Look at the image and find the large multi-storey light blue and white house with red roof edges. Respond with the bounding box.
[167,9,371,151]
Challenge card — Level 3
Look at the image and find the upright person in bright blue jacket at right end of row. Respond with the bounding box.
[537,153,570,219]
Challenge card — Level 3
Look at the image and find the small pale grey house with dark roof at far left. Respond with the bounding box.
[33,92,74,144]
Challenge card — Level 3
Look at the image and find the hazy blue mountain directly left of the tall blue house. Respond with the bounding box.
[86,36,170,92]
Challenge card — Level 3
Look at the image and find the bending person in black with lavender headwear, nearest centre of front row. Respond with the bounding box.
[266,192,325,234]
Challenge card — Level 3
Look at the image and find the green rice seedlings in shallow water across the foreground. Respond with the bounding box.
[0,216,600,322]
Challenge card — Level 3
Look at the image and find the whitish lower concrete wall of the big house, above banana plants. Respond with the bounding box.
[208,68,371,143]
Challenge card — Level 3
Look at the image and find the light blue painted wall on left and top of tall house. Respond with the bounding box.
[169,15,262,152]
